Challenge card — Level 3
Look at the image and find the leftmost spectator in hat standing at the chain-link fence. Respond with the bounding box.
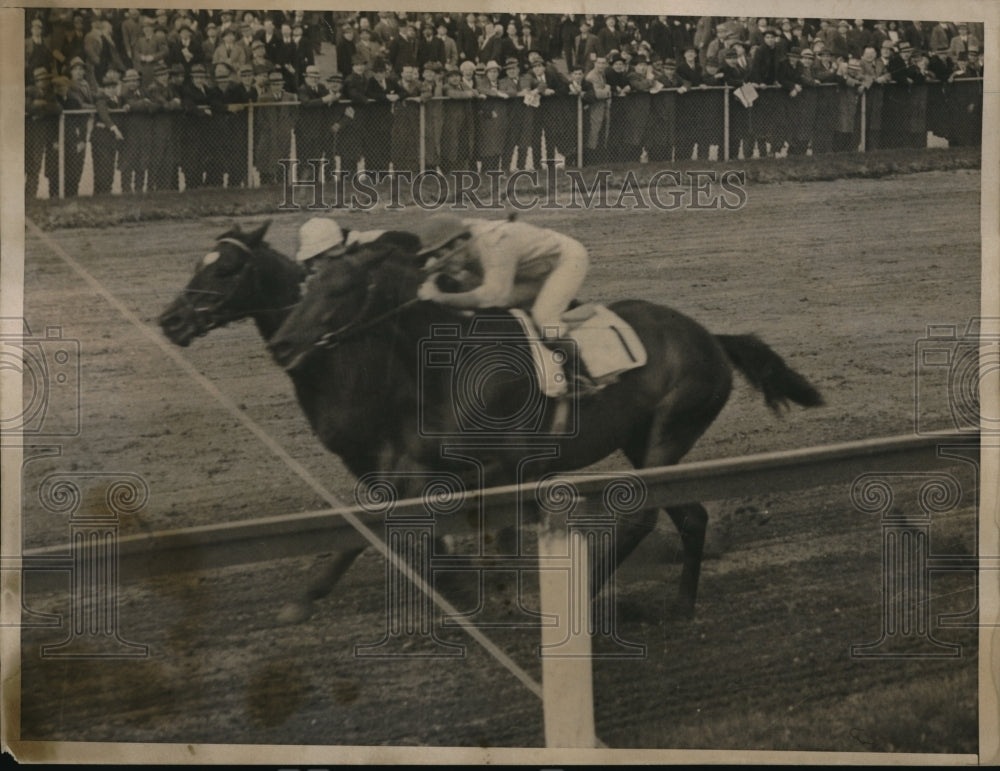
[24,67,62,198]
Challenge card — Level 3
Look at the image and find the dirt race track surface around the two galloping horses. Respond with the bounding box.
[22,172,980,752]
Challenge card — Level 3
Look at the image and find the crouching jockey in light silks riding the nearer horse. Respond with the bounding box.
[417,214,589,340]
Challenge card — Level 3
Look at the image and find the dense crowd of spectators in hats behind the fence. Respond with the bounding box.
[25,8,983,195]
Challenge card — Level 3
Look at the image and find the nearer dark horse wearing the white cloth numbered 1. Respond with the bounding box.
[269,222,822,615]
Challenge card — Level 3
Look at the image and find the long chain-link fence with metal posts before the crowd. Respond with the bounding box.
[25,78,983,198]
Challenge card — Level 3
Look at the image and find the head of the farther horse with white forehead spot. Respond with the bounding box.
[159,221,303,346]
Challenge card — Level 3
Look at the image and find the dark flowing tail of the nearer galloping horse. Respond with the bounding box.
[715,335,823,412]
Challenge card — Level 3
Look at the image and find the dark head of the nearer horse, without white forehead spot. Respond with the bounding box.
[269,238,422,370]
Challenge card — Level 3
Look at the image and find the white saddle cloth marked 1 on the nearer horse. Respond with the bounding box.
[509,303,646,397]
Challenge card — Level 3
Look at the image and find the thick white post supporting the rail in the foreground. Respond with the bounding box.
[538,504,597,747]
